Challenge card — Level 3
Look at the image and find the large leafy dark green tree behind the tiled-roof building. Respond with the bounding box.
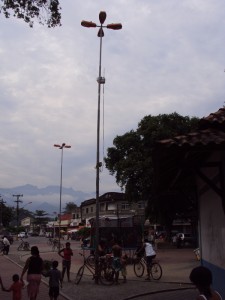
[105,112,199,223]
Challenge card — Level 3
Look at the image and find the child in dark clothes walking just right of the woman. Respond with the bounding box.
[48,260,62,300]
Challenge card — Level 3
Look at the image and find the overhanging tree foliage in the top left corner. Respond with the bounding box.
[0,0,61,27]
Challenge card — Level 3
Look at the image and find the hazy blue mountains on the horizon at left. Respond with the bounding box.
[0,184,95,214]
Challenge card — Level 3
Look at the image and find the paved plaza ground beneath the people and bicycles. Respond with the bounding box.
[0,240,199,300]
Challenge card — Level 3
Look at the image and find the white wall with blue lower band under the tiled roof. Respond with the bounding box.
[198,152,225,299]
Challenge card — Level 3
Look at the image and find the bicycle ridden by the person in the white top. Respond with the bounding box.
[134,257,162,280]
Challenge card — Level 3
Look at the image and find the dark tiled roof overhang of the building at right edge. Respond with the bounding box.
[153,108,225,191]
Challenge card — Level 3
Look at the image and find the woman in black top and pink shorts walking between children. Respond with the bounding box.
[20,246,43,300]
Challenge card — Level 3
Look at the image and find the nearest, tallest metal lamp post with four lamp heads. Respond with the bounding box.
[81,11,122,283]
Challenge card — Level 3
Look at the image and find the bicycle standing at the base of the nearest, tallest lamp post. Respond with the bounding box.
[75,253,114,285]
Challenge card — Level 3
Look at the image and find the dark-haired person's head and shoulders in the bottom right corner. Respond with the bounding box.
[189,266,222,300]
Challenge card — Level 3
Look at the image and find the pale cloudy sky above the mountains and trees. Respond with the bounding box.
[0,0,225,206]
